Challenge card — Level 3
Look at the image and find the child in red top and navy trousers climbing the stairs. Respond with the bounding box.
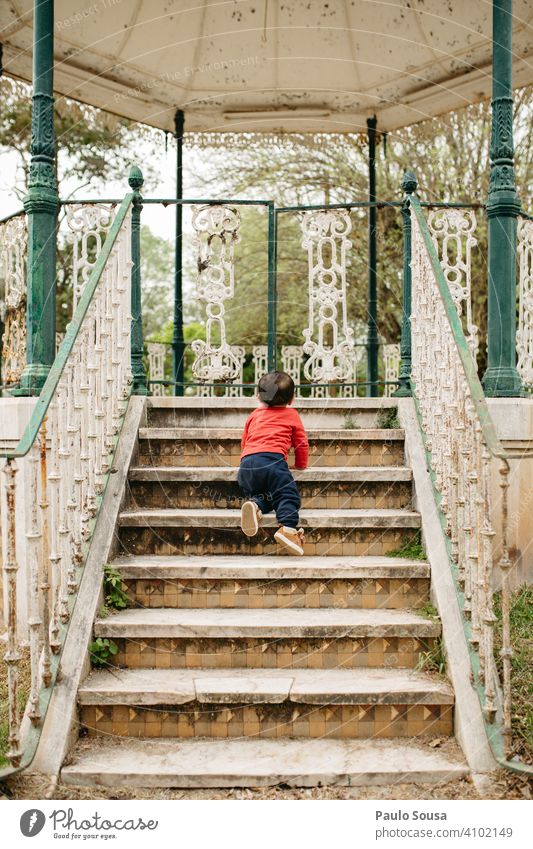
[238,371,309,555]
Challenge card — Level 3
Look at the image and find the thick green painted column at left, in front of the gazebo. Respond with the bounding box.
[13,0,59,395]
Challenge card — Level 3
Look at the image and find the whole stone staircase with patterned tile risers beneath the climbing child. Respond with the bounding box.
[62,398,468,787]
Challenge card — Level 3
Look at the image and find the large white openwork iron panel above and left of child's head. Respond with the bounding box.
[191,205,240,383]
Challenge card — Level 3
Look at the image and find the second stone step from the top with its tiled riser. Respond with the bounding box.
[137,427,405,466]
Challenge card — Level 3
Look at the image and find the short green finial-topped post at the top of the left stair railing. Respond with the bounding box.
[128,165,149,395]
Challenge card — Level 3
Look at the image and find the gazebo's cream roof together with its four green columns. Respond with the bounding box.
[0,0,533,395]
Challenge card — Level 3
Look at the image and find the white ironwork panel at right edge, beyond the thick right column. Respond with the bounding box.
[516,218,533,389]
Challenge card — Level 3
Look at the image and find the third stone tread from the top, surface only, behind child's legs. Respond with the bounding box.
[128,465,413,482]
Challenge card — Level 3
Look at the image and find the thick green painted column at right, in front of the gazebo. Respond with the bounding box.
[483,0,522,397]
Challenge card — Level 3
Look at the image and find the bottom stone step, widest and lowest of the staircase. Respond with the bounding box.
[61,738,469,788]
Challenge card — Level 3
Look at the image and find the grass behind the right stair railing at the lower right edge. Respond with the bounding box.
[494,586,533,765]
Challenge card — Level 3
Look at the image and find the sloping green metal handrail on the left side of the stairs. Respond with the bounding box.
[0,193,133,459]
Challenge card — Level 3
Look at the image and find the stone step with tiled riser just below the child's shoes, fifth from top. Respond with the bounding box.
[113,556,429,609]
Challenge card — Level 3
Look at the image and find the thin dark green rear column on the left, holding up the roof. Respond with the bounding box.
[172,109,185,395]
